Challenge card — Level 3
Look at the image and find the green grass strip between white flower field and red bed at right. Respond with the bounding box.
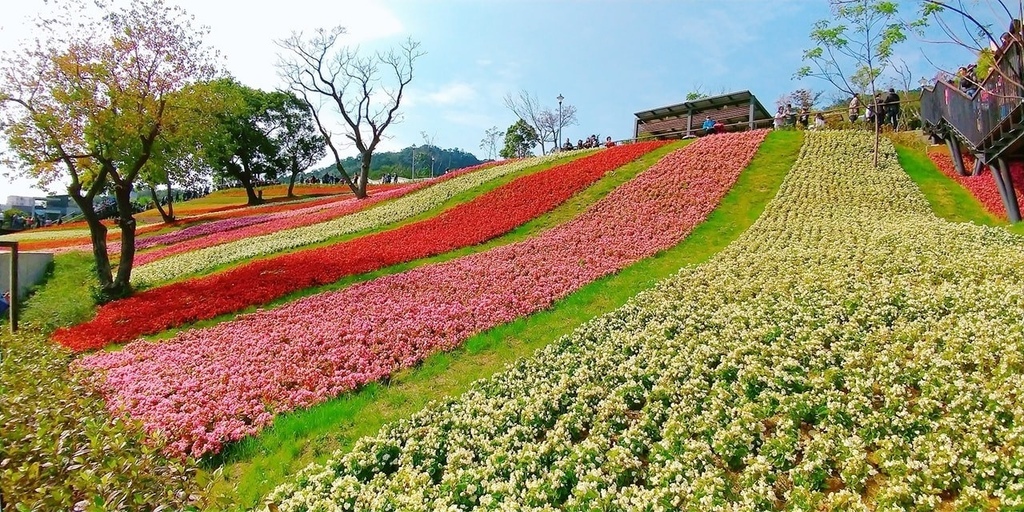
[896,145,1024,234]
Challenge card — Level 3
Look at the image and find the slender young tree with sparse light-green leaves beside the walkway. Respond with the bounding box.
[796,0,906,166]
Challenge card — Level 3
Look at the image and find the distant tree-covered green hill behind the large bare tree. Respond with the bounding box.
[306,145,483,179]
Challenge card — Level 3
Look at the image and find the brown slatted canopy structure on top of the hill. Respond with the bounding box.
[633,91,773,137]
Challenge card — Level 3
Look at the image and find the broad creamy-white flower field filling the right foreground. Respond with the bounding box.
[269,131,1024,511]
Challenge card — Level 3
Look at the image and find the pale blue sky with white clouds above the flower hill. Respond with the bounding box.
[0,0,991,196]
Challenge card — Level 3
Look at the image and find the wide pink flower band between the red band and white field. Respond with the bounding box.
[79,131,766,456]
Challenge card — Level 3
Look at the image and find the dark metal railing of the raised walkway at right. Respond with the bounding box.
[921,40,1024,148]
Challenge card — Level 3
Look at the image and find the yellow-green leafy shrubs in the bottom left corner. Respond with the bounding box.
[0,253,222,511]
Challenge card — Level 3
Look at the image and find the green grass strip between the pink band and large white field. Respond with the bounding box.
[205,131,803,508]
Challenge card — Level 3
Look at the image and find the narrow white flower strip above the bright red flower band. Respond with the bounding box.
[132,150,593,285]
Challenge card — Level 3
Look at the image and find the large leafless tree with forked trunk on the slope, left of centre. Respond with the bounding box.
[276,27,424,198]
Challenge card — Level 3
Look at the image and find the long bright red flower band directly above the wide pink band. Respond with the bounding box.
[53,142,665,351]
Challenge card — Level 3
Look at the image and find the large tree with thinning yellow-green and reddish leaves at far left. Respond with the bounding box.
[0,0,215,298]
